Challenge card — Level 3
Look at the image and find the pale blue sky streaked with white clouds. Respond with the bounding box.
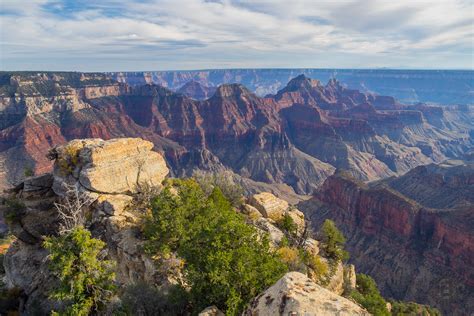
[0,0,474,71]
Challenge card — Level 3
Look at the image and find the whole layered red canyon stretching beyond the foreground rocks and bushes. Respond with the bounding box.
[0,70,474,315]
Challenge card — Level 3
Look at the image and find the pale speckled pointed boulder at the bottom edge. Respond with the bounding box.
[244,272,370,316]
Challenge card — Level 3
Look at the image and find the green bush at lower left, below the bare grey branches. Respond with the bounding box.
[44,227,115,315]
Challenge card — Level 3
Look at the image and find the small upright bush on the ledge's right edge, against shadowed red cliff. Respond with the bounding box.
[320,219,349,260]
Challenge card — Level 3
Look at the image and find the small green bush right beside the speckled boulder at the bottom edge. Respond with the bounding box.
[351,274,390,316]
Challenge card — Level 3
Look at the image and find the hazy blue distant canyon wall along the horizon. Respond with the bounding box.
[110,68,474,105]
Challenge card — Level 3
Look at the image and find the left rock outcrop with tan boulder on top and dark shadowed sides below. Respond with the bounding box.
[4,138,173,311]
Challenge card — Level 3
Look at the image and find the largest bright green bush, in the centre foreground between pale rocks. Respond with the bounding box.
[143,179,286,315]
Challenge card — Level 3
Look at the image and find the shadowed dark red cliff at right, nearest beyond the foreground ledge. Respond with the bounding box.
[299,161,474,315]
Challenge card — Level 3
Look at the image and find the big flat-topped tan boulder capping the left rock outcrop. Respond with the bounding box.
[50,138,169,194]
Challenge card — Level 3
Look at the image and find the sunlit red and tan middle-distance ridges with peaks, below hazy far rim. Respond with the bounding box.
[0,73,473,194]
